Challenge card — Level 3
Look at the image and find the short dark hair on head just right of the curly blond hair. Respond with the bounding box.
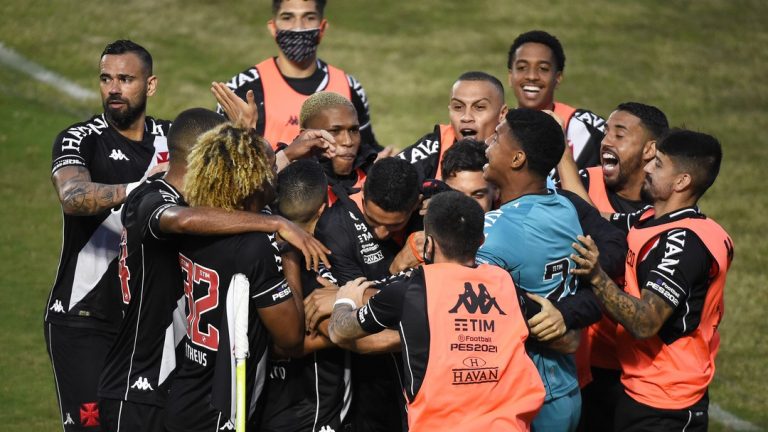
[277,159,328,223]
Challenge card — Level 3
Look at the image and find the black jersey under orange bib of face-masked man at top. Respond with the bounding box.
[217,59,382,151]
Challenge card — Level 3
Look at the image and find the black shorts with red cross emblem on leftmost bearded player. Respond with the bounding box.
[44,323,115,432]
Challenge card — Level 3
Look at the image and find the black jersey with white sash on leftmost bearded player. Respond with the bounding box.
[45,114,170,331]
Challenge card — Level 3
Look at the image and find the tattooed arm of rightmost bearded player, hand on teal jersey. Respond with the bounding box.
[571,236,674,339]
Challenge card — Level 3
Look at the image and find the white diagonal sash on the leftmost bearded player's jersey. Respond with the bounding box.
[67,207,123,310]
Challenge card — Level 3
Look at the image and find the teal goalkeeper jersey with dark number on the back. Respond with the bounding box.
[476,190,582,401]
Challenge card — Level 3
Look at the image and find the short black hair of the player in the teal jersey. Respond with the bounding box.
[506,108,565,177]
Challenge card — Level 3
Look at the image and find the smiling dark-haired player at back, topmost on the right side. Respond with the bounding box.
[507,30,605,168]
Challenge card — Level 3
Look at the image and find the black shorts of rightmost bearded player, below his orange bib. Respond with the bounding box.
[614,392,709,432]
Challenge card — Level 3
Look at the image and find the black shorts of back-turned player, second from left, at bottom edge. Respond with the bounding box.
[99,398,165,432]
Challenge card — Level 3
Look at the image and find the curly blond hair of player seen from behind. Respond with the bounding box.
[184,123,275,210]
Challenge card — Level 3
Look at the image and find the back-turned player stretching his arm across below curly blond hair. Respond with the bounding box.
[98,108,330,431]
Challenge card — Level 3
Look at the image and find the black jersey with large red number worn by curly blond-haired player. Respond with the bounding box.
[166,233,292,431]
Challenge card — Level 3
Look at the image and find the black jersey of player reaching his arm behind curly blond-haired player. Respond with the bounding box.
[99,175,186,407]
